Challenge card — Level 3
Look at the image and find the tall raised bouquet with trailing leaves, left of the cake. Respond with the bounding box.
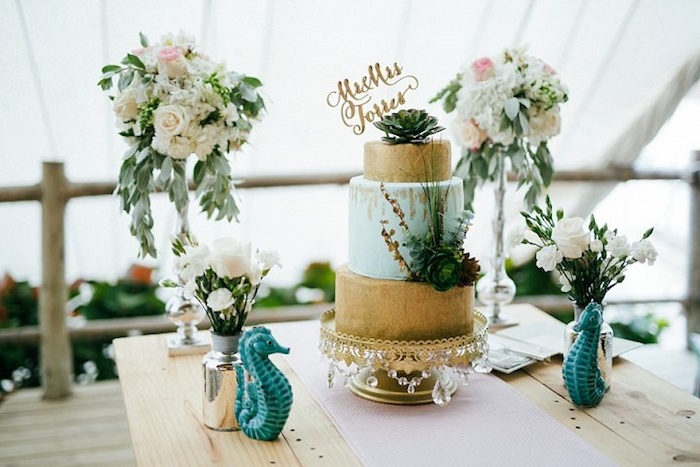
[98,33,265,257]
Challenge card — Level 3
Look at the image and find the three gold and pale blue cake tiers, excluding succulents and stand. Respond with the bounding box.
[335,141,474,341]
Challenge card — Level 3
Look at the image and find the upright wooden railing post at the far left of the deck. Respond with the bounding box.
[39,162,73,399]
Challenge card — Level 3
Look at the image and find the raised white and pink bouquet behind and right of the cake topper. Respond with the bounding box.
[430,48,568,209]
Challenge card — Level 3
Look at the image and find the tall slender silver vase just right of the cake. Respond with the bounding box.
[476,152,515,329]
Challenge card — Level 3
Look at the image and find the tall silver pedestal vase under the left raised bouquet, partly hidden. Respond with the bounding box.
[165,194,209,355]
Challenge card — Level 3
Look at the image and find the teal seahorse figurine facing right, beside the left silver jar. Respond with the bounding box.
[235,326,292,441]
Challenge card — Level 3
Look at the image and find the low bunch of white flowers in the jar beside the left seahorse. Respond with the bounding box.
[161,237,280,335]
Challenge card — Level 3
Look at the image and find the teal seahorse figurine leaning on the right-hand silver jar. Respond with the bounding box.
[562,303,605,407]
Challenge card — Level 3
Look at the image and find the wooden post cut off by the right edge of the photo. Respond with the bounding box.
[687,150,700,348]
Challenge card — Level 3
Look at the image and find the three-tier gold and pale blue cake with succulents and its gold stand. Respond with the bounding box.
[321,110,486,405]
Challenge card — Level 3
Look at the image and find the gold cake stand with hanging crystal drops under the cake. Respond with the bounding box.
[320,309,491,405]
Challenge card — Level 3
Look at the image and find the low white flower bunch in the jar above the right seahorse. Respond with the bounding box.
[510,196,657,308]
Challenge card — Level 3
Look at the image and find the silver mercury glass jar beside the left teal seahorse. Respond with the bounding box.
[202,332,243,431]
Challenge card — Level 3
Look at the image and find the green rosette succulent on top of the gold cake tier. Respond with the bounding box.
[374,109,445,144]
